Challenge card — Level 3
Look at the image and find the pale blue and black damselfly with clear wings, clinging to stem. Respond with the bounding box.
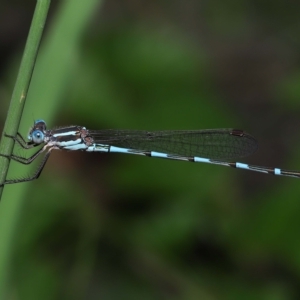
[0,120,300,184]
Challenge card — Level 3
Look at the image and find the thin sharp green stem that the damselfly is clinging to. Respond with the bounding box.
[0,0,51,199]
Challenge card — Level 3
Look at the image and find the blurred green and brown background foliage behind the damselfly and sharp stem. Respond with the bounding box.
[0,0,300,300]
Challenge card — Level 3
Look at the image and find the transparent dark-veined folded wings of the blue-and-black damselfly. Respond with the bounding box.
[89,129,258,159]
